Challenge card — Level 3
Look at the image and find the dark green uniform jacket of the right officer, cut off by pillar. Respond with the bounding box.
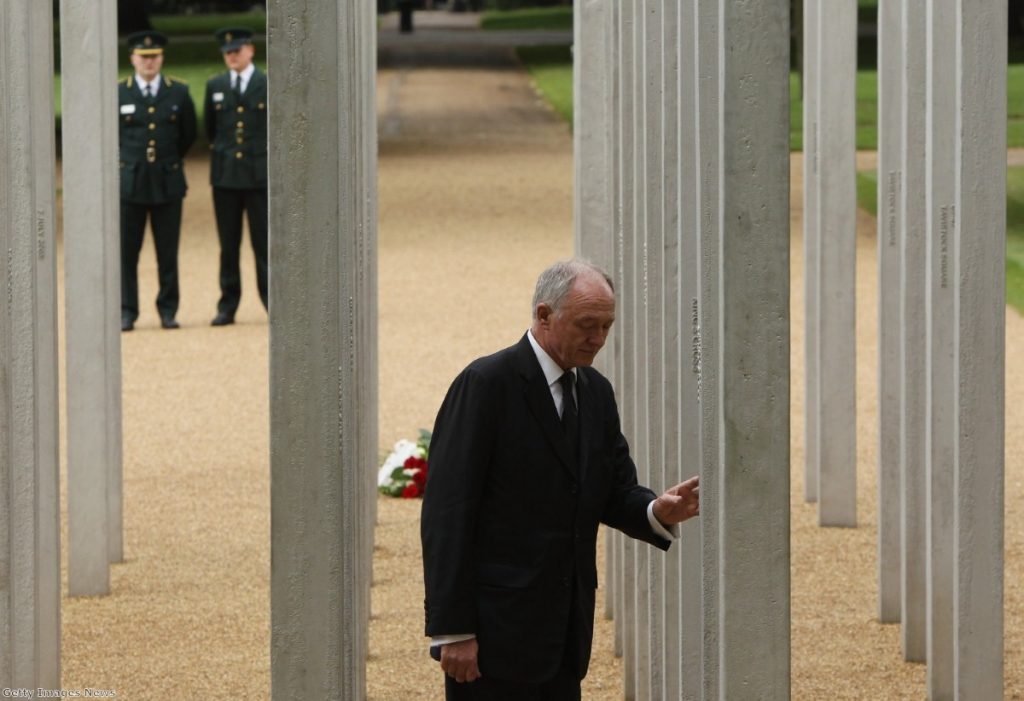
[204,69,267,189]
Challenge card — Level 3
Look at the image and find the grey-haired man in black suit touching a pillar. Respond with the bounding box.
[421,260,699,701]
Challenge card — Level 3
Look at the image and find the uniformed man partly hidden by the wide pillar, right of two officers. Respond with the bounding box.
[204,28,267,326]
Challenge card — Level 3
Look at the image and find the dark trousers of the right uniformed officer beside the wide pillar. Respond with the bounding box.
[213,187,267,316]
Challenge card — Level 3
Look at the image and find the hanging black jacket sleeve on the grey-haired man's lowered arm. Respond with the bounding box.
[420,367,500,636]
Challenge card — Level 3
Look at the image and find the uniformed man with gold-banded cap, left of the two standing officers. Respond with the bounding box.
[118,31,197,331]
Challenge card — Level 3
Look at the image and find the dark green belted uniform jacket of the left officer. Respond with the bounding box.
[118,76,197,205]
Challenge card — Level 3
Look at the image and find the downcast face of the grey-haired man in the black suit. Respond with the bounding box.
[534,273,615,369]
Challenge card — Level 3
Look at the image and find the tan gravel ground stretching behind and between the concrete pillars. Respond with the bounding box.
[63,36,1024,701]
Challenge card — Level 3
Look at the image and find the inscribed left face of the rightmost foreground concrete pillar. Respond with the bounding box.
[925,0,956,700]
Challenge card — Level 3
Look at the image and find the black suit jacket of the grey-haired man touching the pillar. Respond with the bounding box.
[421,336,669,684]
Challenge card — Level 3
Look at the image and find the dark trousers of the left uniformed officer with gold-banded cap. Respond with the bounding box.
[121,200,181,321]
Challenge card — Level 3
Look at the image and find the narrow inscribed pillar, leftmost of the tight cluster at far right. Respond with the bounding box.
[878,0,905,623]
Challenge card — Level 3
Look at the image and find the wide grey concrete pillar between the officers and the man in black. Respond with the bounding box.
[267,0,377,700]
